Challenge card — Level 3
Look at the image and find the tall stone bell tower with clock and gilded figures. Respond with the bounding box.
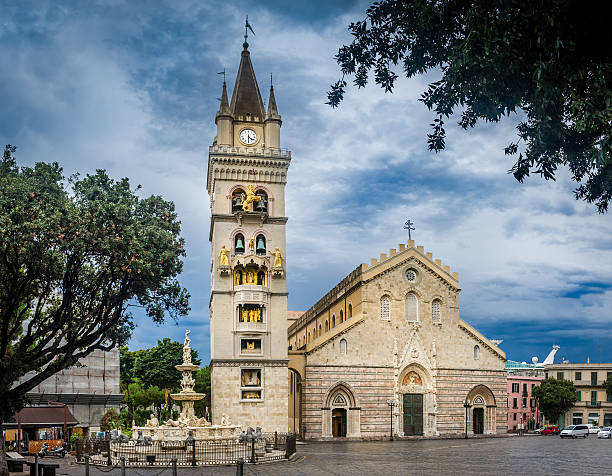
[206,39,291,432]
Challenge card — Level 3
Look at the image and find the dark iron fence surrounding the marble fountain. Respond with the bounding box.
[76,433,296,467]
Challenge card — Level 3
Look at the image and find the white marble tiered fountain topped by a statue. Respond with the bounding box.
[132,330,240,441]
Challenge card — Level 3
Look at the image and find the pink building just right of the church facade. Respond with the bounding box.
[508,374,543,431]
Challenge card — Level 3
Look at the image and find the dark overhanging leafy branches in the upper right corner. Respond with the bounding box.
[328,0,612,213]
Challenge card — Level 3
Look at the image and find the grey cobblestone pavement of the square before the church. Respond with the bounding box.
[16,435,612,476]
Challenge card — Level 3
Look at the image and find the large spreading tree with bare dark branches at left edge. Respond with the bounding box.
[0,145,189,476]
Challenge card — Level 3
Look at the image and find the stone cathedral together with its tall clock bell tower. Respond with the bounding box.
[206,38,507,438]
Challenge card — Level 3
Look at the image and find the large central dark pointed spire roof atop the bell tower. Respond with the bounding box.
[230,43,265,120]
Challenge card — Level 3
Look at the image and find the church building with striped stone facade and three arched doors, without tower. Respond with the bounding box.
[288,241,507,438]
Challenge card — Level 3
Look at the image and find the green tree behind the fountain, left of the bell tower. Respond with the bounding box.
[132,337,200,390]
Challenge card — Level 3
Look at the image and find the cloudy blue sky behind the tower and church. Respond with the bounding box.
[0,0,612,362]
